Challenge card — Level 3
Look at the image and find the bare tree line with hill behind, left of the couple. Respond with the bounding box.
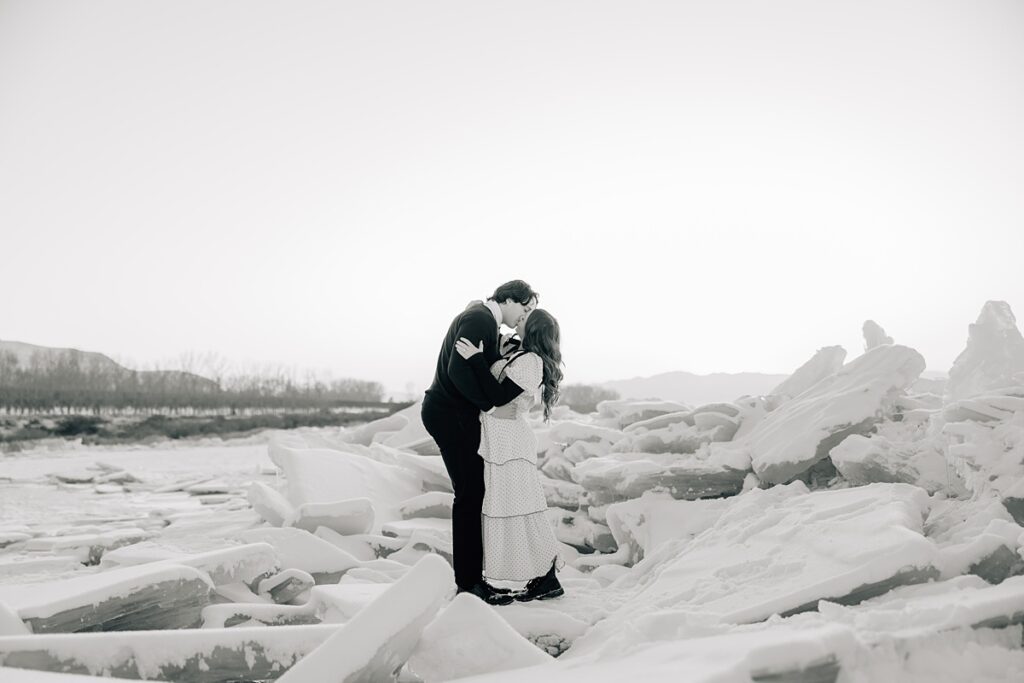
[0,350,384,414]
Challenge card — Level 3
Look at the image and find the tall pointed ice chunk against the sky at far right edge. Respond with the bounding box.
[945,301,1024,400]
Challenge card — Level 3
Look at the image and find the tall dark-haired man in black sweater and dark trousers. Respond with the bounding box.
[421,280,539,604]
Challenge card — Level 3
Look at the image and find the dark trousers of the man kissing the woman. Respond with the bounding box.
[421,394,484,588]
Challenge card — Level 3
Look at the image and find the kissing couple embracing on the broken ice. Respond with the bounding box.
[421,280,564,605]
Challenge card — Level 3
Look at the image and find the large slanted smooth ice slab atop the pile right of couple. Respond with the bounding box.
[746,345,925,483]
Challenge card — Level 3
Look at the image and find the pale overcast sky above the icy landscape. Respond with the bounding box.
[0,0,1024,390]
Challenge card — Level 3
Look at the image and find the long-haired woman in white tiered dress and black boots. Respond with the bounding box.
[456,309,564,601]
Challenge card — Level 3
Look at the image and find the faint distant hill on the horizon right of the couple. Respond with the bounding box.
[601,372,788,405]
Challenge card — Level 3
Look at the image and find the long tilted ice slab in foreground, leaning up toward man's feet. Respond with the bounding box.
[279,556,455,683]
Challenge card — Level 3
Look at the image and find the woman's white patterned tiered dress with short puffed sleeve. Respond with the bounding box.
[480,353,558,581]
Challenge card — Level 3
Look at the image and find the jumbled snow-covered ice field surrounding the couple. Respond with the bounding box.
[6,302,1024,683]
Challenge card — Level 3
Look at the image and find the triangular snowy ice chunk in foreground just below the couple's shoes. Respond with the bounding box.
[409,594,554,683]
